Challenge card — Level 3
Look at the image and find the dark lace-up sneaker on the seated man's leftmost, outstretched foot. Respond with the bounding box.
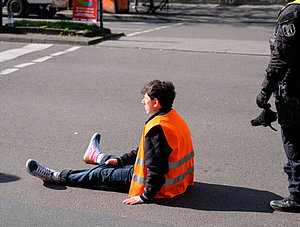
[26,159,58,182]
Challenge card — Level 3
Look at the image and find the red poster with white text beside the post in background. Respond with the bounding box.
[73,0,97,23]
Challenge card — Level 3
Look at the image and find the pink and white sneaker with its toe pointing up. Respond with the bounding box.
[83,133,101,164]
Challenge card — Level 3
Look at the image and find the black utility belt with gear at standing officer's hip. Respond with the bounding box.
[275,80,300,126]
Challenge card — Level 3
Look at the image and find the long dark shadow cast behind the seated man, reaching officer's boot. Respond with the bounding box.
[157,182,282,213]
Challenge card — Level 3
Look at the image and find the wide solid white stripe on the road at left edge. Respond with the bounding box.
[0,44,53,62]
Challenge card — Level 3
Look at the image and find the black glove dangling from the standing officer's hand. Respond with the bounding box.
[251,104,277,131]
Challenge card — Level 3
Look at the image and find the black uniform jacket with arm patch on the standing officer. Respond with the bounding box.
[262,1,300,93]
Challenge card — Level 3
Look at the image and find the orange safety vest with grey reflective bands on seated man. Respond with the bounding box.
[129,110,194,198]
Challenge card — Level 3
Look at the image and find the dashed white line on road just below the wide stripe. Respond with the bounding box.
[0,45,81,75]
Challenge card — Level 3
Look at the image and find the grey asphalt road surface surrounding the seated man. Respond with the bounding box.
[0,22,300,226]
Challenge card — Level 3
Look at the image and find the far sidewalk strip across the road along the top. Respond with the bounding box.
[57,3,282,23]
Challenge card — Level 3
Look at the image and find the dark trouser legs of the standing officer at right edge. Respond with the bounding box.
[281,125,300,201]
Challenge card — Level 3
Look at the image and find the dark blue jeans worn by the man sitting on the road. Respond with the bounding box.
[59,155,134,191]
